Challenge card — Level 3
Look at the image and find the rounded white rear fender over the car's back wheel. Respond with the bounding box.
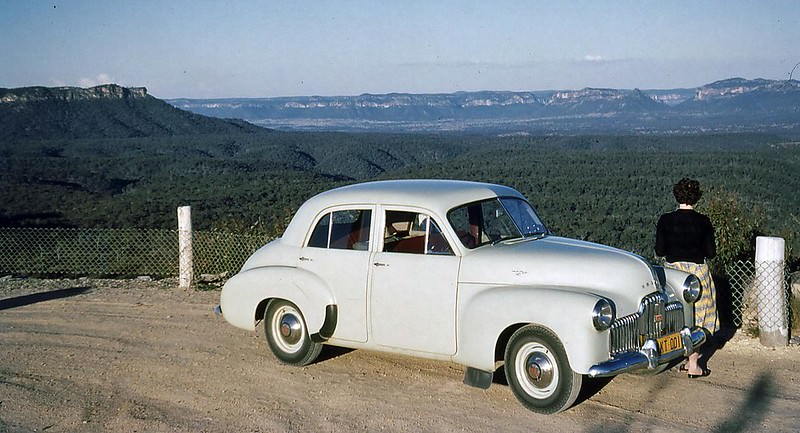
[220,266,336,334]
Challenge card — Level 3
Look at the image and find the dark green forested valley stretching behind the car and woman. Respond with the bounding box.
[0,130,800,269]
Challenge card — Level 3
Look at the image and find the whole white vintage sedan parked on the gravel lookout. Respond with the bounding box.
[219,180,706,413]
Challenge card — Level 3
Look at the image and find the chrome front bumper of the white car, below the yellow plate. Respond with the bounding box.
[589,326,706,377]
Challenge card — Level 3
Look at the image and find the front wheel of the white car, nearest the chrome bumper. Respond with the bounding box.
[505,325,583,414]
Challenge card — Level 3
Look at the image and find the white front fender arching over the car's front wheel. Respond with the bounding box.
[454,285,609,374]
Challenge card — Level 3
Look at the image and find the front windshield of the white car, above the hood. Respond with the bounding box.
[447,197,548,248]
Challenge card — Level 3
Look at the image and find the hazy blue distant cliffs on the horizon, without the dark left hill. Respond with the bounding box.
[166,78,800,135]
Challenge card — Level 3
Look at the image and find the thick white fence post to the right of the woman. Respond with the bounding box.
[755,236,789,347]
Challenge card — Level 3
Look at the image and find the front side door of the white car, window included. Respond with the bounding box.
[369,209,460,355]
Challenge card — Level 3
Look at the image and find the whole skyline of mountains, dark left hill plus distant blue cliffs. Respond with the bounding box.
[0,78,800,141]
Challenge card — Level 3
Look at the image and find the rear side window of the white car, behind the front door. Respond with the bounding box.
[308,209,372,250]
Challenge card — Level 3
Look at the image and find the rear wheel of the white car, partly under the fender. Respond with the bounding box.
[264,299,322,366]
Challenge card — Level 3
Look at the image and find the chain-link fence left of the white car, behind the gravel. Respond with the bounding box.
[0,228,269,278]
